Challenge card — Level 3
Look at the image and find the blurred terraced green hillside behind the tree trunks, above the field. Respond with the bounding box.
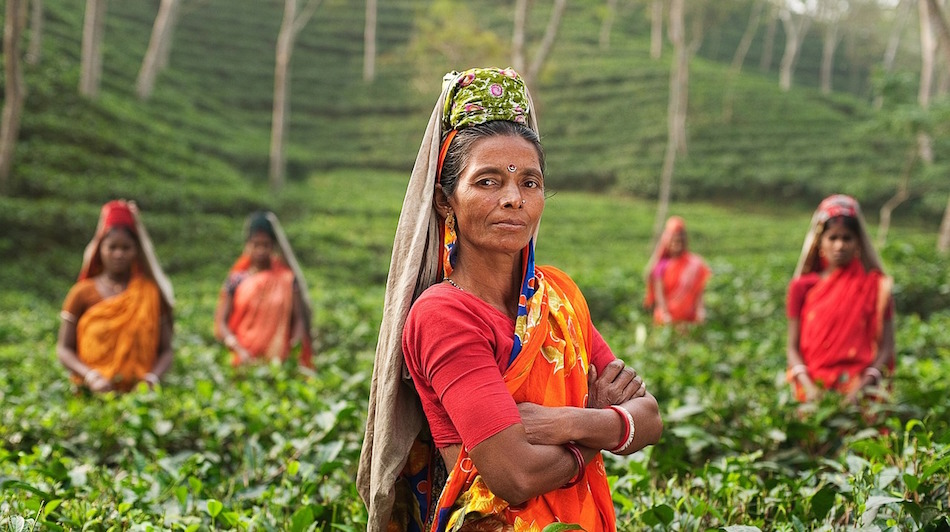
[0,0,950,296]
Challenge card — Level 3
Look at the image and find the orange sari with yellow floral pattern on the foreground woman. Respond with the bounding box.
[432,267,616,532]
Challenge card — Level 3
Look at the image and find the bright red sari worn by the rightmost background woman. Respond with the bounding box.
[799,260,890,393]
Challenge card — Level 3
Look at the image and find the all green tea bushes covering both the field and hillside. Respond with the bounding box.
[0,0,950,531]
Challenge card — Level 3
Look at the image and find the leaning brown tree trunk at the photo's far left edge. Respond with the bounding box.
[0,0,26,194]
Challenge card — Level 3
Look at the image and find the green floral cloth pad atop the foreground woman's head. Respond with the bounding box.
[442,68,530,131]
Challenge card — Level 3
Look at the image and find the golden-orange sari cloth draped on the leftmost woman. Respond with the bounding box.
[74,274,162,391]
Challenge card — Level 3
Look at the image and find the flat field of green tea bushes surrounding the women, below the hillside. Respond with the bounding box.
[0,172,950,530]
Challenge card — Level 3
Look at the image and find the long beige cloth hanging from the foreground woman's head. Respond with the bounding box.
[356,68,538,532]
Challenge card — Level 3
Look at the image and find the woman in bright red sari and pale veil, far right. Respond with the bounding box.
[786,194,894,402]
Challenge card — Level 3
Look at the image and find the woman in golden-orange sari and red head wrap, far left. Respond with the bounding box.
[56,200,174,392]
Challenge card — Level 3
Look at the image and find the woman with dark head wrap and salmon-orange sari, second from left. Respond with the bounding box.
[214,211,313,367]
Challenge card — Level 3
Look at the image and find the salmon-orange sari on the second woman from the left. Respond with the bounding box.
[215,254,306,366]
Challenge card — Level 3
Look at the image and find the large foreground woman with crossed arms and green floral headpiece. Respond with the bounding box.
[357,69,662,532]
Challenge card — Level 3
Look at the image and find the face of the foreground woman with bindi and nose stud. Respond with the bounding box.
[448,136,544,255]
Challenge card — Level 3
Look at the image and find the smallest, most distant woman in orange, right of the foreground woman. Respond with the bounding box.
[643,216,710,324]
